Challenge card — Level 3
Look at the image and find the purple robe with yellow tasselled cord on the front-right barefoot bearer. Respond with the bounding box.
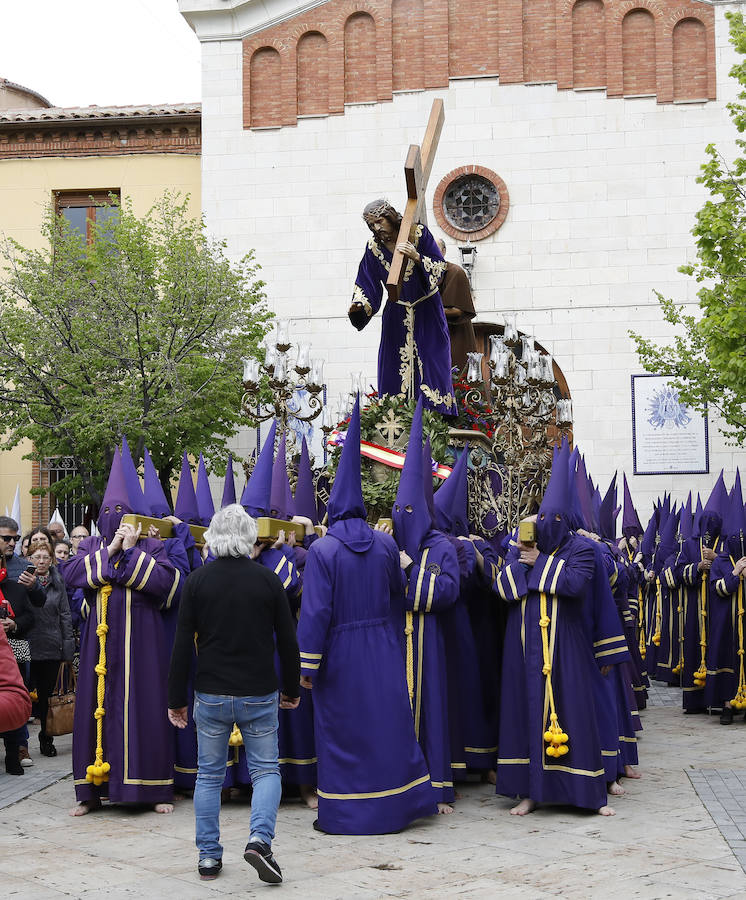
[494,536,608,809]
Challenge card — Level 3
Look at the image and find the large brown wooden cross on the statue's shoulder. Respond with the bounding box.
[386,99,445,303]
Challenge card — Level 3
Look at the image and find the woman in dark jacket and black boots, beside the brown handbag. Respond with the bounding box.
[28,540,75,756]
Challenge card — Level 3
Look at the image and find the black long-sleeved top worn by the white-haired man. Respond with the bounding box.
[168,556,300,709]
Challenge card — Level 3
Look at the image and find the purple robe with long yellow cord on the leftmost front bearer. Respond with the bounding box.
[65,537,179,804]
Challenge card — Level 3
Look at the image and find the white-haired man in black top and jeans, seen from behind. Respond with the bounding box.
[168,503,300,884]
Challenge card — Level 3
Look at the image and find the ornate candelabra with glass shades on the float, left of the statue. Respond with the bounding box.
[241,319,326,454]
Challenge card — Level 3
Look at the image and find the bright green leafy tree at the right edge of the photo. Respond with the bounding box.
[630,12,746,444]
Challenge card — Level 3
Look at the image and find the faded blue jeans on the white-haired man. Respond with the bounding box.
[194,691,282,859]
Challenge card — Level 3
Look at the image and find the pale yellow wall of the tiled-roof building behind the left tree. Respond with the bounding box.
[0,153,201,531]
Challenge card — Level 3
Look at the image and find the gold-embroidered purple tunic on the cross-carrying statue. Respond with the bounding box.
[352,225,456,415]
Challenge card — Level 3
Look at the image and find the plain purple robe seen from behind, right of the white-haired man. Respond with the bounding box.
[298,518,437,834]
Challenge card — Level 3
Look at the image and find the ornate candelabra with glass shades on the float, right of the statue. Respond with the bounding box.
[466,313,572,532]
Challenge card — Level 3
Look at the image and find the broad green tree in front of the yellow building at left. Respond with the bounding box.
[0,194,271,503]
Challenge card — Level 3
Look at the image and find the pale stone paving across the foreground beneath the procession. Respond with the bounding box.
[0,708,746,900]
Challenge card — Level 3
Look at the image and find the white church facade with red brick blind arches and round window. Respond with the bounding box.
[180,0,746,508]
